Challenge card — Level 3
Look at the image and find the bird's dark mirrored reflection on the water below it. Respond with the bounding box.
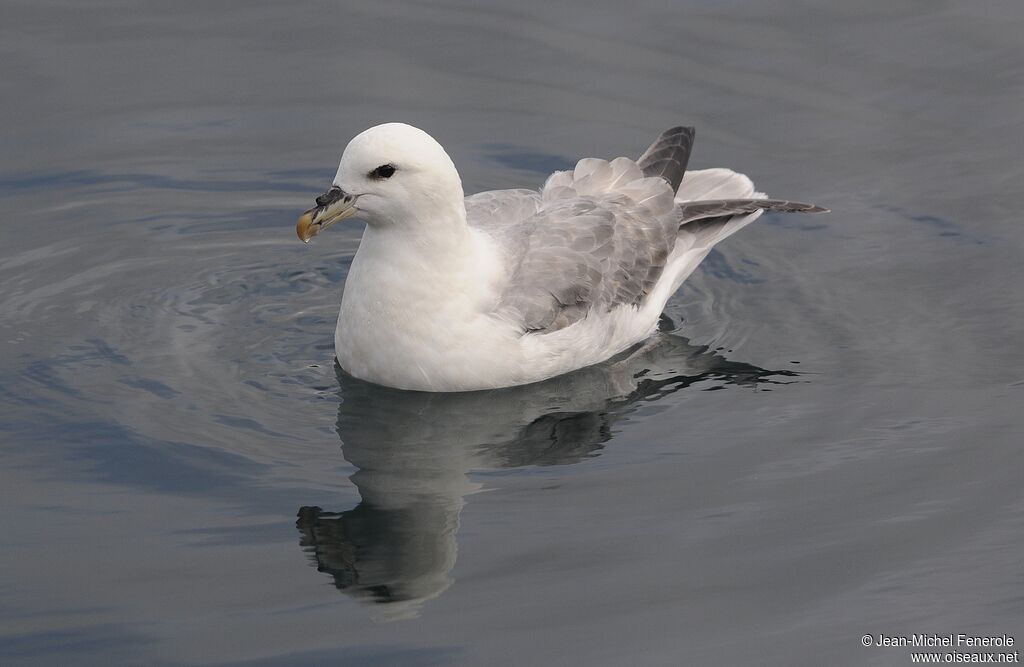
[297,323,796,619]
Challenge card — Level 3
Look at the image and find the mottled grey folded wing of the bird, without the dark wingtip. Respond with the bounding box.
[487,200,678,333]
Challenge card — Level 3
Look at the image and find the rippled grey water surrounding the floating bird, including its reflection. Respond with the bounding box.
[0,0,1024,667]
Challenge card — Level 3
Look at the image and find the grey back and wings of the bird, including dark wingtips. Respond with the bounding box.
[466,127,825,333]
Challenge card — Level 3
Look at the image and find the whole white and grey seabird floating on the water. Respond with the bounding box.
[296,123,826,391]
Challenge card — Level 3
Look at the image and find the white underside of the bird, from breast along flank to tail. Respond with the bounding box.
[335,225,672,391]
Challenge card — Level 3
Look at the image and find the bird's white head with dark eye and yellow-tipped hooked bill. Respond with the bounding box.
[296,123,465,241]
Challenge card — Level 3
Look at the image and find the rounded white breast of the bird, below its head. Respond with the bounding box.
[335,228,521,391]
